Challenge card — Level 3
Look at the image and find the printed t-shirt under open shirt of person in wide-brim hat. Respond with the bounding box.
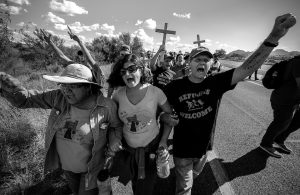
[56,106,93,173]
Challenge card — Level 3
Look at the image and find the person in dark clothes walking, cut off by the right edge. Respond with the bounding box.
[260,56,300,158]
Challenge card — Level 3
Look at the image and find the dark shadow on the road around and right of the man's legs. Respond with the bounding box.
[153,148,269,195]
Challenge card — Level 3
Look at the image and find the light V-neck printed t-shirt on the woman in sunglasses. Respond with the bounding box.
[113,84,167,148]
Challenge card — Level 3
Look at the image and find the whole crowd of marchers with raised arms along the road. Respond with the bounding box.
[0,14,300,195]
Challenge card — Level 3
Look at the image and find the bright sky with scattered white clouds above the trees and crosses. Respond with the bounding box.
[0,0,300,52]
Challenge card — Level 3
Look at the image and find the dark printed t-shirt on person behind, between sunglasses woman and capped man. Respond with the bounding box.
[152,67,176,90]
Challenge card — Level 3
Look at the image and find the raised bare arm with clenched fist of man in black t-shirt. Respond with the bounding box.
[231,13,296,85]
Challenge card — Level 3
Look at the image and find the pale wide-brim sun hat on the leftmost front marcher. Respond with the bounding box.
[43,64,101,87]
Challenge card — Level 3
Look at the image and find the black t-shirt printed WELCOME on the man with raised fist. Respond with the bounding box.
[165,69,236,158]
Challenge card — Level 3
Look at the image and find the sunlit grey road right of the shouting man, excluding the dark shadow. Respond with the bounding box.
[214,81,300,194]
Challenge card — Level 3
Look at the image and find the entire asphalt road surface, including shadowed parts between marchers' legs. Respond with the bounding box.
[113,75,300,195]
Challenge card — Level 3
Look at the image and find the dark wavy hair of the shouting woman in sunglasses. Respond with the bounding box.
[107,54,151,87]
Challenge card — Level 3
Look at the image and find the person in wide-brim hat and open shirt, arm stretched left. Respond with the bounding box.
[0,64,122,195]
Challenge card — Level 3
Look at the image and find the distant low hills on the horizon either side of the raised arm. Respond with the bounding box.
[227,49,300,58]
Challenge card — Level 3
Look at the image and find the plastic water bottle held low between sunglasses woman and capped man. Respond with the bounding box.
[156,146,170,178]
